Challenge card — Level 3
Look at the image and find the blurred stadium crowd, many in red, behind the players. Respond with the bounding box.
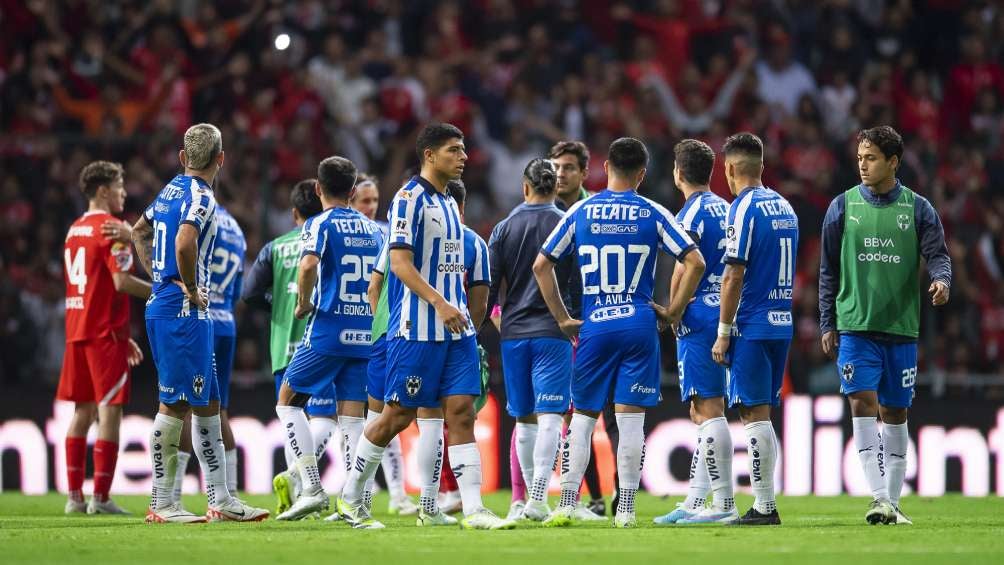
[0,0,1004,393]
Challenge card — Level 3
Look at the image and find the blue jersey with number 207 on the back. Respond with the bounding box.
[541,190,697,335]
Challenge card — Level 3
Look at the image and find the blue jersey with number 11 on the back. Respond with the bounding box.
[725,187,798,339]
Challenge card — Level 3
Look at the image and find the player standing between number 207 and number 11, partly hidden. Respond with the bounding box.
[655,139,739,524]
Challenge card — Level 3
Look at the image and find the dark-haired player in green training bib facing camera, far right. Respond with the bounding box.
[819,125,952,524]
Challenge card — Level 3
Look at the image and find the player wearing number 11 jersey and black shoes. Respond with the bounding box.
[711,132,798,526]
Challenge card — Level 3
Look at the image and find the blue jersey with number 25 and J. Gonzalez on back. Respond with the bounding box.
[300,208,384,358]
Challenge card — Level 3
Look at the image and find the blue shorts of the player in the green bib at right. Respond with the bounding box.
[836,334,917,408]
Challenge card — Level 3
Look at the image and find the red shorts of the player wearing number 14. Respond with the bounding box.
[56,335,130,405]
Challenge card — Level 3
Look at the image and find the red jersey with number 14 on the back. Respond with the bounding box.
[63,212,133,342]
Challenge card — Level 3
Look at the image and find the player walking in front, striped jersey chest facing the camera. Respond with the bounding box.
[338,123,515,530]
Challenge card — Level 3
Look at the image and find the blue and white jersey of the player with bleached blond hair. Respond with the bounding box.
[143,175,217,319]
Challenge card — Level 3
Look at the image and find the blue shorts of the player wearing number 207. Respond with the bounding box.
[571,329,662,411]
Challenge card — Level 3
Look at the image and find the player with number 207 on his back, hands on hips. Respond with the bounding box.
[533,137,704,528]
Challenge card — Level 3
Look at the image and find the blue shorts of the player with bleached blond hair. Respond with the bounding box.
[147,316,220,406]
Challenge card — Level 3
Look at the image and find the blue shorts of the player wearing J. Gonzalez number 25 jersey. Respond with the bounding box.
[283,346,368,415]
